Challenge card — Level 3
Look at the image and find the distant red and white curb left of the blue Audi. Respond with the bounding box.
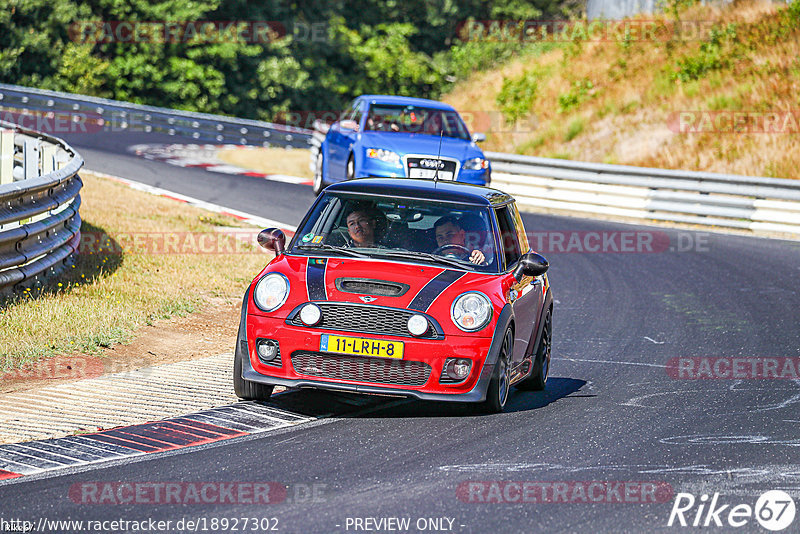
[128,144,313,185]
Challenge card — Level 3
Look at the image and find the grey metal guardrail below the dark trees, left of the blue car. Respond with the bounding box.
[0,84,311,148]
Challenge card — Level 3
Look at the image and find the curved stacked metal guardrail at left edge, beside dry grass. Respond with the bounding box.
[0,121,83,293]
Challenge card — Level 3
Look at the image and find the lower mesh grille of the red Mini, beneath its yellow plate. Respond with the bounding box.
[292,351,431,386]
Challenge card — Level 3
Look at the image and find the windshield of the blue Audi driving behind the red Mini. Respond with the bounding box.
[364,104,470,141]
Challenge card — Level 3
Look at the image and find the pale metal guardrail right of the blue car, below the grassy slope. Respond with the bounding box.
[486,152,800,234]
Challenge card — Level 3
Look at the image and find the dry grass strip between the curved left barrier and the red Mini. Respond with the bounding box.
[0,173,270,370]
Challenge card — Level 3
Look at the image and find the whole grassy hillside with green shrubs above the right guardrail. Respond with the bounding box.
[442,0,800,178]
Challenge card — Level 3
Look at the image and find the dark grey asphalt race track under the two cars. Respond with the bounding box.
[0,131,800,533]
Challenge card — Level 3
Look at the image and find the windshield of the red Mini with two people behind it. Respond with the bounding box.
[292,193,499,272]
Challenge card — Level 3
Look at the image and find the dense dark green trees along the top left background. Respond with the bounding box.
[0,0,572,119]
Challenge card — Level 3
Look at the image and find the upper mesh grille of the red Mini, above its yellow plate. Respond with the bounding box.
[291,302,439,339]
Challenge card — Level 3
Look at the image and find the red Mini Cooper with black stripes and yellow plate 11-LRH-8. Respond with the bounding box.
[233,178,553,412]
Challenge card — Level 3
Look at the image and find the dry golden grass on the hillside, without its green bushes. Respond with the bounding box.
[443,0,800,178]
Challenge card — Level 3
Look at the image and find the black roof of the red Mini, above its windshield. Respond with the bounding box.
[325,178,514,206]
